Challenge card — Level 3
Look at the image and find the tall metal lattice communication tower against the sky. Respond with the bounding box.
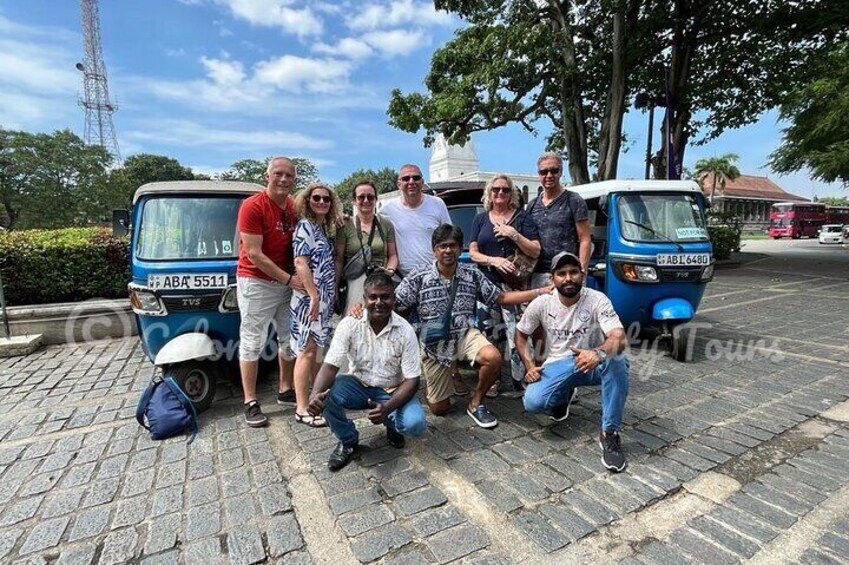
[76,0,121,163]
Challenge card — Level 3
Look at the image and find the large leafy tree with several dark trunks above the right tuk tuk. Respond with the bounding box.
[387,0,847,184]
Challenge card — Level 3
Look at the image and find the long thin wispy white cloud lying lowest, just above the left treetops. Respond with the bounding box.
[125,120,332,152]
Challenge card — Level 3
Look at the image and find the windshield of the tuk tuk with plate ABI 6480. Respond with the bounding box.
[619,193,708,242]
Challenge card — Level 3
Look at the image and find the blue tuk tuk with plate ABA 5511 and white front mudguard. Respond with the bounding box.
[117,180,263,411]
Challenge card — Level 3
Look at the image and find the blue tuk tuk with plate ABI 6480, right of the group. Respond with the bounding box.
[571,180,715,361]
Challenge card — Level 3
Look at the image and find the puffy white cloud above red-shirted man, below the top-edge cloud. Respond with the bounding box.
[254,55,353,93]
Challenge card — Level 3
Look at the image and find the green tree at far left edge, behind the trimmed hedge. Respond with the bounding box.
[0,129,112,229]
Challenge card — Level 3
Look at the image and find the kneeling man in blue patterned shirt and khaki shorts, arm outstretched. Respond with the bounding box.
[395,224,551,428]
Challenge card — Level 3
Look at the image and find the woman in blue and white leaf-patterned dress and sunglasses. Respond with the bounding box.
[291,184,342,427]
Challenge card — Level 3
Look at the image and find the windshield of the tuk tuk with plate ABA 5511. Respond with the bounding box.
[136,196,245,261]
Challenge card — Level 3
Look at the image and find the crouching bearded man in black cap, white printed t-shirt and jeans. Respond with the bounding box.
[516,251,628,473]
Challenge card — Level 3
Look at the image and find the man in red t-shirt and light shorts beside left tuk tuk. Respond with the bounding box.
[236,157,304,427]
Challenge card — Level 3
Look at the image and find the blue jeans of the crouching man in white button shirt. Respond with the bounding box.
[324,375,426,447]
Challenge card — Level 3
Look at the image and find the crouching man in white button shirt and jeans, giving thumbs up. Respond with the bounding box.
[309,273,425,471]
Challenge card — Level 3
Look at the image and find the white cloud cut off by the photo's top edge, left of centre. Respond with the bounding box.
[211,0,324,37]
